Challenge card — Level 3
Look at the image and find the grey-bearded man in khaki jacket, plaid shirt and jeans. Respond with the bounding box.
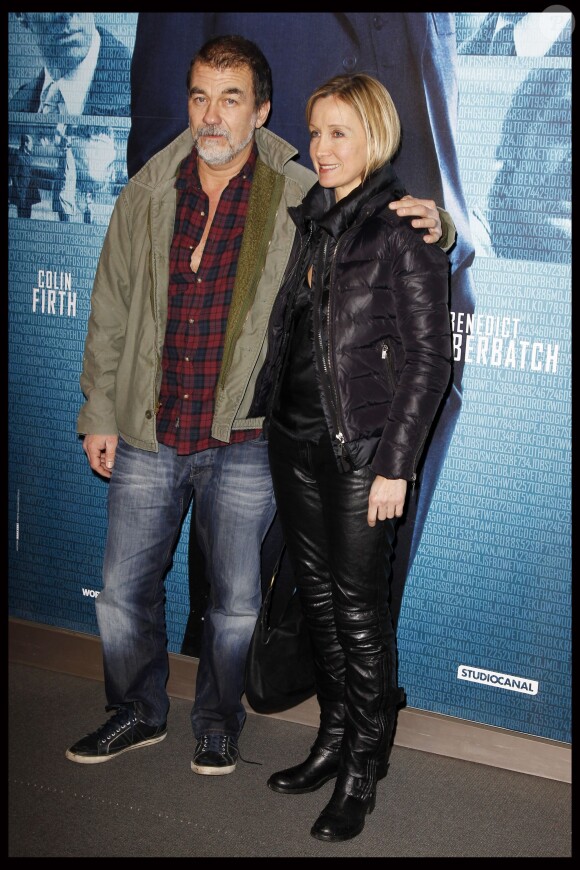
[66,36,448,775]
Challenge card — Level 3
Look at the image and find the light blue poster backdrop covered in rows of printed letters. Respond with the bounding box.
[8,13,573,742]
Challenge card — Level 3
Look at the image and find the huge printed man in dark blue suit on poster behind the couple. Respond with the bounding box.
[127,11,475,640]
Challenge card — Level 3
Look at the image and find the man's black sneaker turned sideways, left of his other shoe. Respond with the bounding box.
[66,707,167,764]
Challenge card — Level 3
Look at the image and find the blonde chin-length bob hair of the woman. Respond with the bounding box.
[306,73,401,181]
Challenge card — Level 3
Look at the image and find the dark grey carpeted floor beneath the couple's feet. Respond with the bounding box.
[8,664,572,858]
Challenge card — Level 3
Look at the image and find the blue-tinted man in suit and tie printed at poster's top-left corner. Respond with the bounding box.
[8,12,131,116]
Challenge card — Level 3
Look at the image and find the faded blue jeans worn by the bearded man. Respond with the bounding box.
[96,437,276,739]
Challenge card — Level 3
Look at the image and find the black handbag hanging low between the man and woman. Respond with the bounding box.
[246,549,316,713]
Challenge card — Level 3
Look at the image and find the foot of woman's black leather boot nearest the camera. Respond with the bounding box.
[310,777,376,843]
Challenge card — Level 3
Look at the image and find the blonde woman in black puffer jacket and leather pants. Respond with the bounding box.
[267,74,451,841]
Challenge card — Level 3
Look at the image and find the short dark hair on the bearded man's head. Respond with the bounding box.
[186,35,272,109]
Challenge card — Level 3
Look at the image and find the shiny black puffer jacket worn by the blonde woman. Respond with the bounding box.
[257,164,452,480]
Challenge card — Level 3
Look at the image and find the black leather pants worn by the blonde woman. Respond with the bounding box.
[269,426,401,798]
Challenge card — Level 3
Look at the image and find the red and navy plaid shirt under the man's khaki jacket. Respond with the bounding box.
[157,148,259,454]
